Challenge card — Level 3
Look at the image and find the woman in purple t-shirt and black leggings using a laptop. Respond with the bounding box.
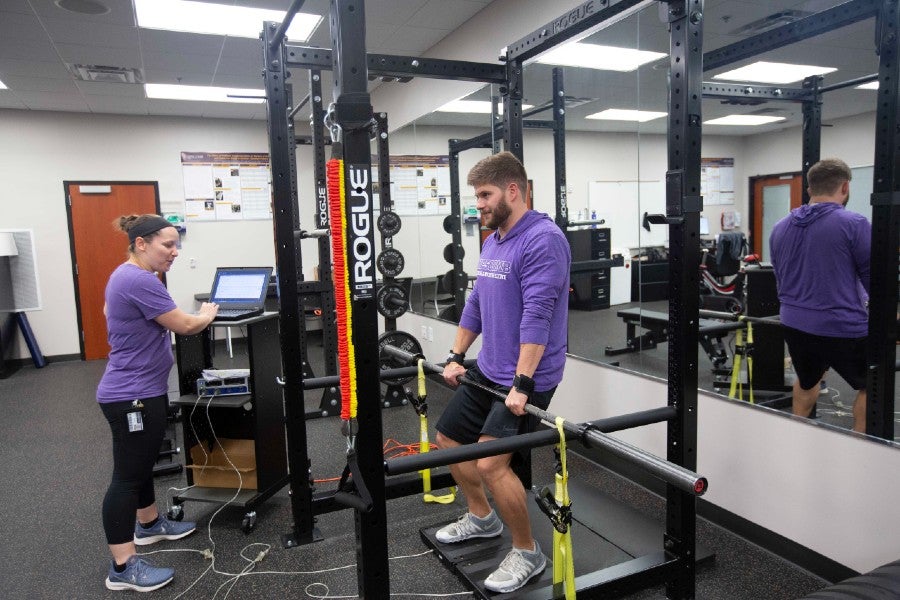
[97,215,219,592]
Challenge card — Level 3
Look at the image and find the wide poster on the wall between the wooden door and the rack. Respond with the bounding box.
[181,152,272,221]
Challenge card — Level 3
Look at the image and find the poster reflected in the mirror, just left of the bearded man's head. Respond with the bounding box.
[372,154,450,217]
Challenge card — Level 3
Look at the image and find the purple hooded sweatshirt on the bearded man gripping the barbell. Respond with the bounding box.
[459,211,571,392]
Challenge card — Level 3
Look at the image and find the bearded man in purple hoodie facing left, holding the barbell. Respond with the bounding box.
[436,152,571,593]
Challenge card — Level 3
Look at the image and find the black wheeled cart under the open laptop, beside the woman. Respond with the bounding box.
[173,312,288,533]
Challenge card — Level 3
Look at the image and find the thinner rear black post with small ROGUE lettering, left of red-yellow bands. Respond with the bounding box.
[309,69,341,416]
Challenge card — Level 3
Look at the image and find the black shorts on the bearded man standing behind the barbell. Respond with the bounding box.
[436,365,556,444]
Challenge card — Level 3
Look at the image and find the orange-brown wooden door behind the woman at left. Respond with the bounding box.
[64,181,159,360]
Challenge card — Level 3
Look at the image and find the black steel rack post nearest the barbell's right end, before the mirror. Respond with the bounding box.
[660,0,703,598]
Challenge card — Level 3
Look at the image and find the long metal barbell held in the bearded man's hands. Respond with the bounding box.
[382,345,709,496]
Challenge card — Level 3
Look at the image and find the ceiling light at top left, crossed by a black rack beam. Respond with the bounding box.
[134,0,322,42]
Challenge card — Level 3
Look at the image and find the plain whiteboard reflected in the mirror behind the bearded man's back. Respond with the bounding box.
[588,181,669,248]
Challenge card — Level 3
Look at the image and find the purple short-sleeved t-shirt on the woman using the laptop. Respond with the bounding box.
[97,263,176,402]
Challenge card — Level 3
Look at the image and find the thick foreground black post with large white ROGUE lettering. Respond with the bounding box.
[331,0,390,598]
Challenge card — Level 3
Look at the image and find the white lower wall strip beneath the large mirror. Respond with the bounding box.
[398,314,900,572]
